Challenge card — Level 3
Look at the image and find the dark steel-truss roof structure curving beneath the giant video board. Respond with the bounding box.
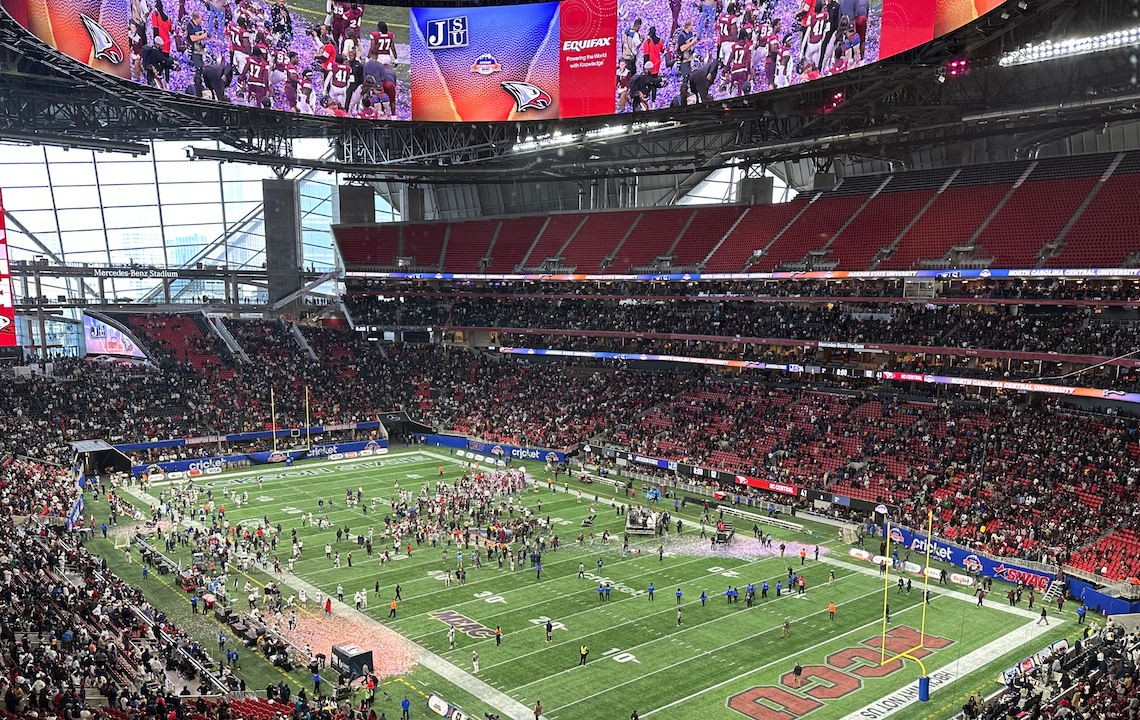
[0,0,1140,204]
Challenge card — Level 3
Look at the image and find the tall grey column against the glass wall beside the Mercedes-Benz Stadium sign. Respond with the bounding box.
[261,180,304,312]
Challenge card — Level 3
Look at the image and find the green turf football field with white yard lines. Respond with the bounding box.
[100,450,1075,720]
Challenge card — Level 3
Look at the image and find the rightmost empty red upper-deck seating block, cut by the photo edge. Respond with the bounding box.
[1045,174,1140,268]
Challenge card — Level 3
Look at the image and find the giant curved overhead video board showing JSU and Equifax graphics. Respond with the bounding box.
[0,0,1001,122]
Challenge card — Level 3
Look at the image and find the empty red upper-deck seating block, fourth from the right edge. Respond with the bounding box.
[828,190,934,270]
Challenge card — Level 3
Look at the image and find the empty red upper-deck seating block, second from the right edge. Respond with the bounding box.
[974,175,1096,268]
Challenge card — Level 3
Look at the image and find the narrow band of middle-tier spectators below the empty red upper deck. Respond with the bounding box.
[350,295,1140,357]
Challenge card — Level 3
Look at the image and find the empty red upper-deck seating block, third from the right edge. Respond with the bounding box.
[878,185,1009,270]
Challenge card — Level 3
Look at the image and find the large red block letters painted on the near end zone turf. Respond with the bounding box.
[727,625,954,720]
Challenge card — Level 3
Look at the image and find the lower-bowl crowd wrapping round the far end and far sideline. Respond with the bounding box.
[0,309,1138,576]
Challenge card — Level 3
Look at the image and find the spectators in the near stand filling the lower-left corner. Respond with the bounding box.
[0,458,241,719]
